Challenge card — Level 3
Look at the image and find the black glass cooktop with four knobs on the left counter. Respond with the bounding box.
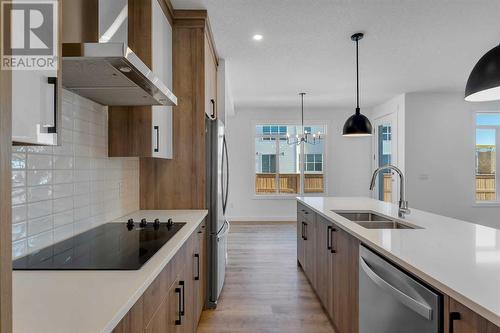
[13,220,186,270]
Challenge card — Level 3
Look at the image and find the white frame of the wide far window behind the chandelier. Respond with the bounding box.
[254,120,329,200]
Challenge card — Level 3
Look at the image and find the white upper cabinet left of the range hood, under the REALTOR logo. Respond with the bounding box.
[10,1,61,145]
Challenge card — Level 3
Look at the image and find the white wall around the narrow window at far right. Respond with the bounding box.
[405,93,500,228]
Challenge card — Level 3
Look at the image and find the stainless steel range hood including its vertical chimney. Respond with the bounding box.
[62,0,177,106]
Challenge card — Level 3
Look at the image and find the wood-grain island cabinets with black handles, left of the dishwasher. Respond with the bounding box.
[297,205,360,333]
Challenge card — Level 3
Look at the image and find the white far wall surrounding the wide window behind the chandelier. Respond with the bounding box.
[226,108,371,221]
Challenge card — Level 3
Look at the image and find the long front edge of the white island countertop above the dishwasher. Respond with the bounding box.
[296,197,500,327]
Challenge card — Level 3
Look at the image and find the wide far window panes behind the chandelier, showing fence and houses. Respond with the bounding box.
[255,124,326,195]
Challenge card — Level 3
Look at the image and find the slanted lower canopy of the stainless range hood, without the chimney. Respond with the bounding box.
[62,43,177,106]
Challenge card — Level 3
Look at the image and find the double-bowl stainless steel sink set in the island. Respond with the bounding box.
[332,210,422,229]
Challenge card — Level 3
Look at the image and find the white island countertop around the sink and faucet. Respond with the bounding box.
[298,197,500,326]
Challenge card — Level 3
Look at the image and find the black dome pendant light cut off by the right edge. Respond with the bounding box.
[465,45,500,102]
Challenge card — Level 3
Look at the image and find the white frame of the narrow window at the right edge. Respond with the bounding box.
[472,110,500,207]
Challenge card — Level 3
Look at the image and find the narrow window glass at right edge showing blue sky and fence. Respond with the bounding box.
[475,113,500,202]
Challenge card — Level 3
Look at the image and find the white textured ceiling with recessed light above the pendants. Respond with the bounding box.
[172,0,500,108]
